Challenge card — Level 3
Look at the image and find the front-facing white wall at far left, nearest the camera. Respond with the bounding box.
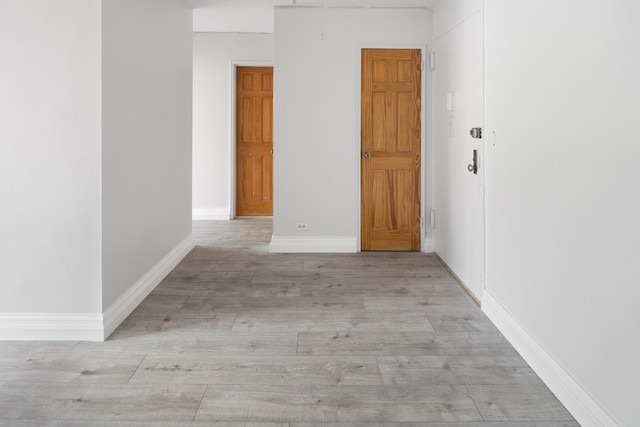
[0,0,101,324]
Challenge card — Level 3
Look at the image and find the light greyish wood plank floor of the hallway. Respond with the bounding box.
[0,218,578,427]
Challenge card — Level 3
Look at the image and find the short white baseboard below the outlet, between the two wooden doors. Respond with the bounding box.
[269,236,358,253]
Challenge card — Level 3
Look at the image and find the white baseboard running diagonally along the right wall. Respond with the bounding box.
[482,289,618,427]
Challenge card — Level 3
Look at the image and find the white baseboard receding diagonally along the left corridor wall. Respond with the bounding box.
[102,234,195,339]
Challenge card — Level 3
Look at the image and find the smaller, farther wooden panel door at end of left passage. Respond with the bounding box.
[236,67,273,216]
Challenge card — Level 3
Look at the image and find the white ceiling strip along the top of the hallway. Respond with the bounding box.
[190,0,440,33]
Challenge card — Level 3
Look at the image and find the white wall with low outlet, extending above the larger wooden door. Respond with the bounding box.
[271,7,432,251]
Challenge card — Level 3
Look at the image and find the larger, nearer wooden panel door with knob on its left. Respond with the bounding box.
[361,49,422,251]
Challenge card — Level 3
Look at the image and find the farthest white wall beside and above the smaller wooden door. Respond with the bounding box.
[193,33,273,219]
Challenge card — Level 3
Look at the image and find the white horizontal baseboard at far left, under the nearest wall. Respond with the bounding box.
[0,313,103,341]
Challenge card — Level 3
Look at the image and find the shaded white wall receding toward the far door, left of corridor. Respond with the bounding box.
[102,0,192,323]
